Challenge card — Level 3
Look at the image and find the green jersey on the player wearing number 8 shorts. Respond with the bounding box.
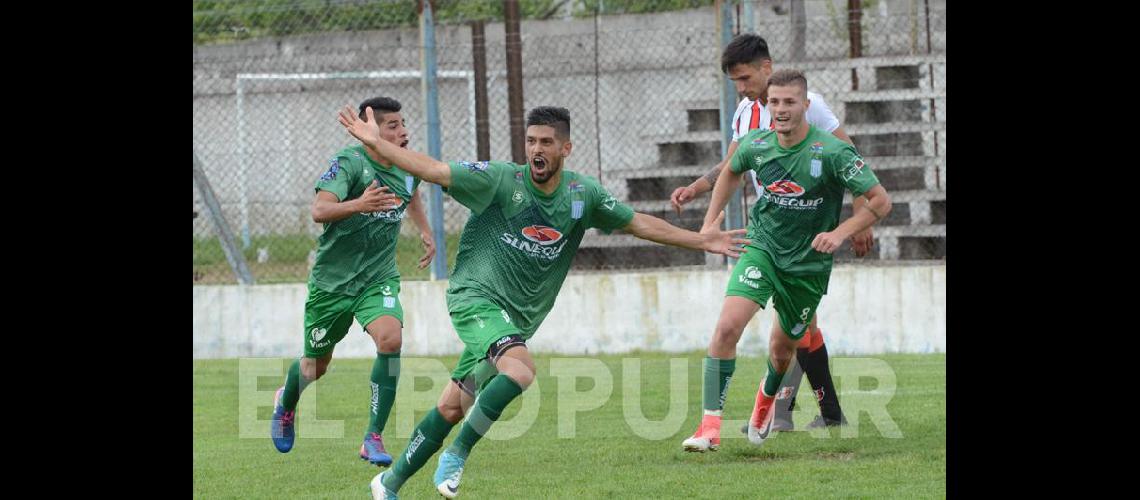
[732,125,879,276]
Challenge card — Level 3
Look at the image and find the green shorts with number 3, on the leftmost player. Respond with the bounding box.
[304,277,404,358]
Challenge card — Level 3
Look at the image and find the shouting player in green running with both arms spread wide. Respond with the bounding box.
[340,103,748,498]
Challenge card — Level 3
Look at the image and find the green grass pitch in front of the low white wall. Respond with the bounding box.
[194,352,946,499]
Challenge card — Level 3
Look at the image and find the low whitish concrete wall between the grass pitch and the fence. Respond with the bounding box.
[194,263,946,358]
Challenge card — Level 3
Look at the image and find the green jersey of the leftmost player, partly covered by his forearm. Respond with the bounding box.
[309,146,420,295]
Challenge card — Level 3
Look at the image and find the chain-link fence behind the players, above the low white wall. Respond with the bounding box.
[194,0,945,284]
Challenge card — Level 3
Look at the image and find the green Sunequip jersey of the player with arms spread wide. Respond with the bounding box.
[447,162,634,338]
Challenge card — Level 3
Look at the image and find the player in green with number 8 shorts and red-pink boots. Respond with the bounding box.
[682,69,890,451]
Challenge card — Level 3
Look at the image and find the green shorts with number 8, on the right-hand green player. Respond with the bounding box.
[725,246,831,341]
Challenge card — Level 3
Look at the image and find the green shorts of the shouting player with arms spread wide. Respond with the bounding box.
[451,301,529,394]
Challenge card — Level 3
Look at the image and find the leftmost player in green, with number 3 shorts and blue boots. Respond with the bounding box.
[270,97,435,466]
